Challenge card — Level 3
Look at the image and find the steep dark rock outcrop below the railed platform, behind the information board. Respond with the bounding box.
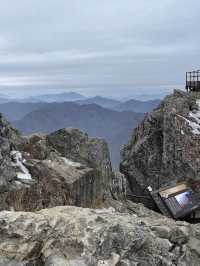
[120,91,200,207]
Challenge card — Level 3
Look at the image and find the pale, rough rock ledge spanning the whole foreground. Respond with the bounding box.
[0,205,200,266]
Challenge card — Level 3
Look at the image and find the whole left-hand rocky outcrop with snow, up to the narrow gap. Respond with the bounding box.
[0,123,114,211]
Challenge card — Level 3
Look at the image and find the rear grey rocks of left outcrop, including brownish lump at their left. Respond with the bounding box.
[21,128,113,188]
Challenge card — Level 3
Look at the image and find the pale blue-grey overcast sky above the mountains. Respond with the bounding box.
[0,0,200,97]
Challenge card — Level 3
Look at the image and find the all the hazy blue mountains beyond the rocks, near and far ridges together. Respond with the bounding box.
[0,92,160,166]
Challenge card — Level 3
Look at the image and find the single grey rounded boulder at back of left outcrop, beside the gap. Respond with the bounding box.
[47,128,112,190]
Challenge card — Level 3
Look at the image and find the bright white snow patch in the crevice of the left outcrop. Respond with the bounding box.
[11,151,32,180]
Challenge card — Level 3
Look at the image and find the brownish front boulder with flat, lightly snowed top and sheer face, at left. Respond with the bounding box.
[1,153,105,211]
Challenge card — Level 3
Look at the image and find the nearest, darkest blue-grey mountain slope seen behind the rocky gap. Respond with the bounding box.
[14,102,143,166]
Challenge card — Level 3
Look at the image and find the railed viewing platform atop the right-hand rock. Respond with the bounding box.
[185,70,200,92]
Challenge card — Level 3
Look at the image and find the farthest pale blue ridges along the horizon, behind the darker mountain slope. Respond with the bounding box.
[0,92,160,121]
